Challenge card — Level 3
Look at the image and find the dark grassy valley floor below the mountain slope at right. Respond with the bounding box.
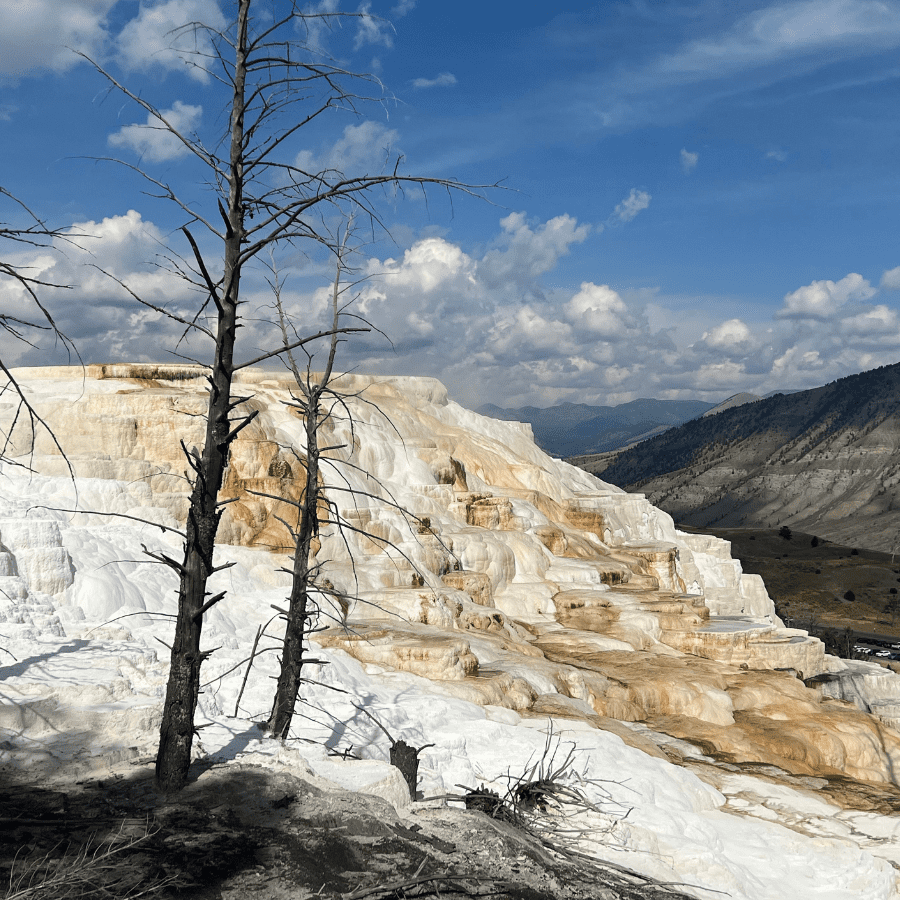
[678,525,900,640]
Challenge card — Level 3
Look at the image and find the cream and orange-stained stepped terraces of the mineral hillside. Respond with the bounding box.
[0,365,900,780]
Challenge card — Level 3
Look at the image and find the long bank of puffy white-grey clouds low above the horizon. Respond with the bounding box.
[7,202,900,406]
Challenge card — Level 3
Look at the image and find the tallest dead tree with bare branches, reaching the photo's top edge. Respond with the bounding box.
[82,0,492,791]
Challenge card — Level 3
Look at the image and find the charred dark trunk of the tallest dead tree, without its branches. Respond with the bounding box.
[156,0,250,792]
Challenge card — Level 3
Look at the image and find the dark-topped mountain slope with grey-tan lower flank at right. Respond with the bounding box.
[578,364,900,552]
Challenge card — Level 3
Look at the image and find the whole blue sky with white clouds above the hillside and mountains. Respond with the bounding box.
[0,0,900,406]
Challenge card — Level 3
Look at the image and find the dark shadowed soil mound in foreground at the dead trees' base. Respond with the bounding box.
[0,764,688,900]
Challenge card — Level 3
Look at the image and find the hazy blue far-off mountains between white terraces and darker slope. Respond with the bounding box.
[477,400,716,458]
